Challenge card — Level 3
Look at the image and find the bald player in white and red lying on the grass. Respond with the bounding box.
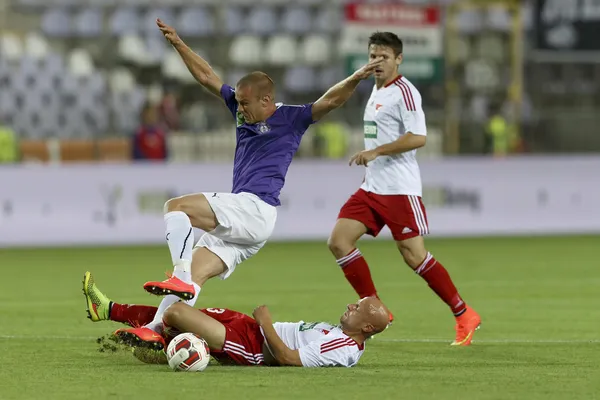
[83,272,389,367]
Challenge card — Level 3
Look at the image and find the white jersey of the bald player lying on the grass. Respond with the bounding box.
[273,321,364,367]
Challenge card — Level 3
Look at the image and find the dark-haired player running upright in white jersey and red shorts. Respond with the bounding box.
[328,32,481,346]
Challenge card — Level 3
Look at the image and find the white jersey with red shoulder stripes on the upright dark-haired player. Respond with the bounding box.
[361,75,427,196]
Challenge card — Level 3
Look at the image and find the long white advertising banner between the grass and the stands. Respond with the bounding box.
[0,157,600,247]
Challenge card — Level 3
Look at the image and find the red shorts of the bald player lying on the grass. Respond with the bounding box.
[200,308,265,365]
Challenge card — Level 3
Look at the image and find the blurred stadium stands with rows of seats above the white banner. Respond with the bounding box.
[0,0,600,162]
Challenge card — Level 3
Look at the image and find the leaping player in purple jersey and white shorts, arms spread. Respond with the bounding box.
[115,20,381,349]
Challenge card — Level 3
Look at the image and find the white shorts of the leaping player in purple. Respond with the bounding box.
[196,192,277,279]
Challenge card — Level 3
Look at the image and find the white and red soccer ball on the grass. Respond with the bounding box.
[167,333,210,372]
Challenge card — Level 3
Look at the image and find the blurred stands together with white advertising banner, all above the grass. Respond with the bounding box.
[0,0,600,245]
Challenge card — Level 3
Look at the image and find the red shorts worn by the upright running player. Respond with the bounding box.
[338,189,429,241]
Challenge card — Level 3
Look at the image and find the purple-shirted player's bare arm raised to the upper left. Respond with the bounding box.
[156,19,223,99]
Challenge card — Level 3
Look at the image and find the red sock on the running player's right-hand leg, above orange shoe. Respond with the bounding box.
[415,253,467,316]
